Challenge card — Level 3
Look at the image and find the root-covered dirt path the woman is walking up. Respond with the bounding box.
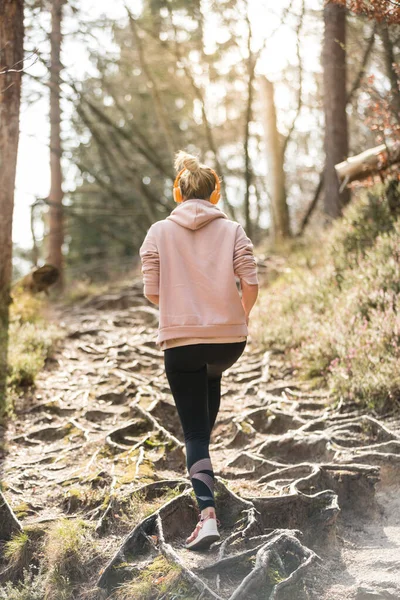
[2,281,400,600]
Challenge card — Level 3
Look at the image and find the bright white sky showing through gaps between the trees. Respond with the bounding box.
[13,0,321,255]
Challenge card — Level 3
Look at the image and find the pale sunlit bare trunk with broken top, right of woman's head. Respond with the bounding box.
[260,77,291,243]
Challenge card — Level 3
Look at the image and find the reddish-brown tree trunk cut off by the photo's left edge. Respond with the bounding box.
[0,0,24,416]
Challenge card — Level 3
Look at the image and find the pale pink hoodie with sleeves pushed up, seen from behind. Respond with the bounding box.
[139,199,258,345]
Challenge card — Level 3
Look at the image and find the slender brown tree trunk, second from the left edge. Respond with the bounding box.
[47,0,65,289]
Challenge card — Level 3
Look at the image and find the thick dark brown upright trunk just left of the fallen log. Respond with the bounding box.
[322,2,350,219]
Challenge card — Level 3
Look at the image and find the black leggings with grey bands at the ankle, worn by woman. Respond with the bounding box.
[164,341,246,510]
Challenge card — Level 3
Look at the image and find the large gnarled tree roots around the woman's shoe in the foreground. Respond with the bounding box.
[97,478,339,600]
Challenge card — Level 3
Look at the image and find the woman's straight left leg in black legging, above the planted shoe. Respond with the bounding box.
[164,344,215,511]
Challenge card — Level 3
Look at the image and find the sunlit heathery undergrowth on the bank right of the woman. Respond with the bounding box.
[254,183,400,411]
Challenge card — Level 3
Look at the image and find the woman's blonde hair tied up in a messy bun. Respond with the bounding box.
[175,150,216,200]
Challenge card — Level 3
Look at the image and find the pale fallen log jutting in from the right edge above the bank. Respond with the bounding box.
[335,142,400,188]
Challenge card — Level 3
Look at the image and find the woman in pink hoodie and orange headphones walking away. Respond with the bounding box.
[139,151,258,550]
